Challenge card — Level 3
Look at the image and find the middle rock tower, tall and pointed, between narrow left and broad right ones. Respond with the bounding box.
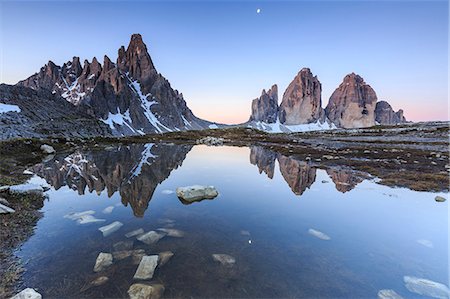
[280,68,325,125]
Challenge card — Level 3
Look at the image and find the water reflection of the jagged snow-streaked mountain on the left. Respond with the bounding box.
[34,144,192,217]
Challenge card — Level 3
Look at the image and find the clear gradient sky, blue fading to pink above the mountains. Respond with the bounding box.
[0,0,449,123]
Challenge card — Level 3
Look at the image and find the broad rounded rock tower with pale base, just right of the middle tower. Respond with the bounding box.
[325,73,377,128]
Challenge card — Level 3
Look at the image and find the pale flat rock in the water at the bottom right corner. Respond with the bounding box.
[403,276,450,299]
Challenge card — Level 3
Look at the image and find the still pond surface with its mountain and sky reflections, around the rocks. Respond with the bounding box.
[17,144,449,298]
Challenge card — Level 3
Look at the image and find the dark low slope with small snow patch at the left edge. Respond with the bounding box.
[0,84,111,140]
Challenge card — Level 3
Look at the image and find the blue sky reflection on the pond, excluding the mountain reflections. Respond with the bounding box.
[15,146,448,297]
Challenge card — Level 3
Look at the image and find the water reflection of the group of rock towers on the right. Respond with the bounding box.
[250,146,363,195]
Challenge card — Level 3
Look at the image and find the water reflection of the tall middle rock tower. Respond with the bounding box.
[278,155,316,195]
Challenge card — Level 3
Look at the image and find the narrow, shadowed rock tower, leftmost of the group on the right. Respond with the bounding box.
[250,84,278,123]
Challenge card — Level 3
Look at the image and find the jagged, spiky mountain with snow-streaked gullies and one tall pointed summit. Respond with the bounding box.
[18,34,215,135]
